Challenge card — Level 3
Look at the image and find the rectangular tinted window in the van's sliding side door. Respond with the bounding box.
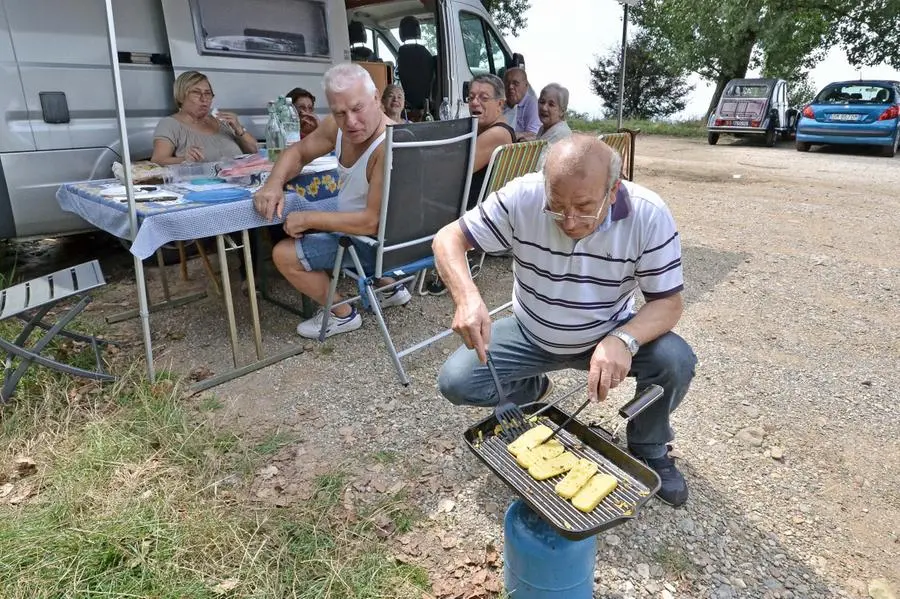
[190,0,331,59]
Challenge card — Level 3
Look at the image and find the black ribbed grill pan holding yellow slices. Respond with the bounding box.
[464,403,660,541]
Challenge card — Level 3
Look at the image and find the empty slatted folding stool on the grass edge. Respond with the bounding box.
[0,260,115,402]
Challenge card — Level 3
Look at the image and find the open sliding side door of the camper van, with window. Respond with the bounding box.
[162,0,350,129]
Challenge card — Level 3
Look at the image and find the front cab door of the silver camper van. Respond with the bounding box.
[446,0,512,116]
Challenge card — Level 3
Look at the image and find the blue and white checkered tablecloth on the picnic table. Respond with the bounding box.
[56,164,340,259]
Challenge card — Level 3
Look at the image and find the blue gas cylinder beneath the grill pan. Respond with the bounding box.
[503,500,597,599]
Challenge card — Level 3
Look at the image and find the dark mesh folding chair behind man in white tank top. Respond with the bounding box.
[319,118,478,385]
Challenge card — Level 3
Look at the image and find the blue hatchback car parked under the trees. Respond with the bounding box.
[797,80,900,157]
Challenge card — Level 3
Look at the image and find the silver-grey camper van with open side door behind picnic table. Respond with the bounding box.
[0,0,522,244]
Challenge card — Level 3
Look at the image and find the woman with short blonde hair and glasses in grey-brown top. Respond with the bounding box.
[150,71,258,165]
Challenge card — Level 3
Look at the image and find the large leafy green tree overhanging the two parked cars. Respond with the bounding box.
[634,0,900,117]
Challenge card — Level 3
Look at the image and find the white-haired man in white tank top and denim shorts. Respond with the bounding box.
[253,63,410,339]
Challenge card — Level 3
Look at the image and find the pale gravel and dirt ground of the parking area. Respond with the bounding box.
[3,137,900,599]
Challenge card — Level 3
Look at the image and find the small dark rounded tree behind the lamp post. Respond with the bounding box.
[590,31,694,119]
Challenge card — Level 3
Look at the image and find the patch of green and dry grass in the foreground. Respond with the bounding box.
[0,369,428,599]
